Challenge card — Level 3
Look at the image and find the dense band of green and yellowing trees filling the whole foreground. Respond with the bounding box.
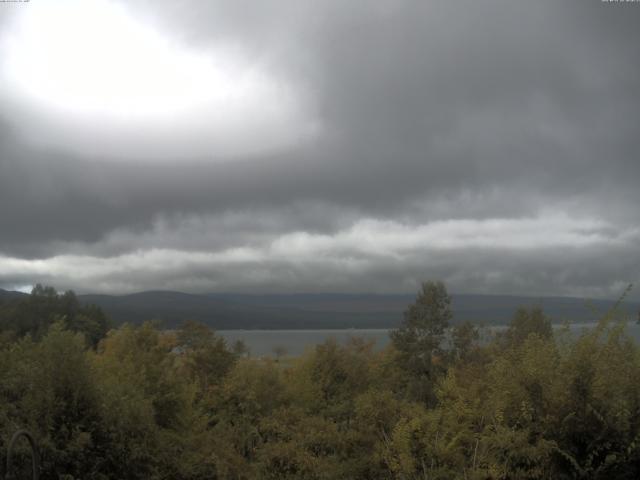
[0,282,640,480]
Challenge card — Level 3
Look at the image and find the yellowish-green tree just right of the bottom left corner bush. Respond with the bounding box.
[92,322,206,480]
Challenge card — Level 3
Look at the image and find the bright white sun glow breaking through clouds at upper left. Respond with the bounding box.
[0,0,315,161]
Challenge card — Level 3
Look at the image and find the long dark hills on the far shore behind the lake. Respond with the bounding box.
[62,291,640,329]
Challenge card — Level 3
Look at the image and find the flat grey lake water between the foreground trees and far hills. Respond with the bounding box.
[217,323,640,356]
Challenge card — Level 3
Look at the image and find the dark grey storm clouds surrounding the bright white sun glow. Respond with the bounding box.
[0,0,640,295]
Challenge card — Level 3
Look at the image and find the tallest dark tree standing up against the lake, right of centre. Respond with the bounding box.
[391,281,452,404]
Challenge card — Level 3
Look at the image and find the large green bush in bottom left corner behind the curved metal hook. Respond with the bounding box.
[0,323,101,478]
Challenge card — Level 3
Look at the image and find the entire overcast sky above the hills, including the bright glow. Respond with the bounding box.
[0,0,640,298]
